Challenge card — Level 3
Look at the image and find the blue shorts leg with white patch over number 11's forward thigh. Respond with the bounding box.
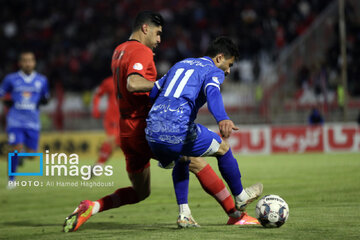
[182,124,223,157]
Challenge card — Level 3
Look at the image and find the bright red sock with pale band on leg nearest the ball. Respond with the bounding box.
[196,164,236,214]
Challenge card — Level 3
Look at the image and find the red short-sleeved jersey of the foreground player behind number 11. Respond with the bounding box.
[111,40,157,137]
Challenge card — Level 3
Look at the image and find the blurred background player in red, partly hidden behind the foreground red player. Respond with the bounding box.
[92,76,120,165]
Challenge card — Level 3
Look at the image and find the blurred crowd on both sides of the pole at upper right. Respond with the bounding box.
[296,2,360,105]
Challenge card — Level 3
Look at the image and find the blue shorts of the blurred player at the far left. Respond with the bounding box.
[7,128,40,151]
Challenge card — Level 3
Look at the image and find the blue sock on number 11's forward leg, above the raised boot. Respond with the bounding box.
[216,148,243,196]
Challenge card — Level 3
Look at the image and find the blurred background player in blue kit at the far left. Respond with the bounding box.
[0,51,49,187]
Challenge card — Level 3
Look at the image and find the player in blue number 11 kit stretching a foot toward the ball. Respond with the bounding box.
[145,37,263,227]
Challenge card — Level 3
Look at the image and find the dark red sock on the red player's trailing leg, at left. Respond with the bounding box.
[98,187,139,212]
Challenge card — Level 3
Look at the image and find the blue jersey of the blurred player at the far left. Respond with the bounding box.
[0,71,49,130]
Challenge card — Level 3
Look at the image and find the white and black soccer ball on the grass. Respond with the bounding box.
[255,195,289,228]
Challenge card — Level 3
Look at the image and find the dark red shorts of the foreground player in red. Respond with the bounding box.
[120,134,153,173]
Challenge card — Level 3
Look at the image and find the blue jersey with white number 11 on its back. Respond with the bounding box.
[145,57,229,144]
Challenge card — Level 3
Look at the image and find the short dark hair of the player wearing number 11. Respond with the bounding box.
[205,36,240,60]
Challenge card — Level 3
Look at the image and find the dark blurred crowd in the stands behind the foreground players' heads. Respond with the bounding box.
[0,0,329,91]
